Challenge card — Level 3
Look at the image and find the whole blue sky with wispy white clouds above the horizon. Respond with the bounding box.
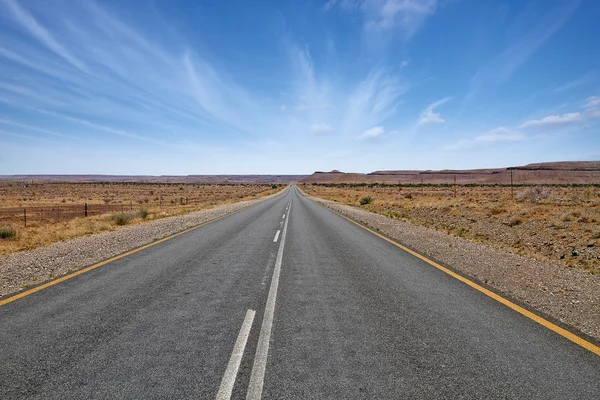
[0,0,600,175]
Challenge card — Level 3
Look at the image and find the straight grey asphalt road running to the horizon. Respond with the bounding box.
[0,187,600,399]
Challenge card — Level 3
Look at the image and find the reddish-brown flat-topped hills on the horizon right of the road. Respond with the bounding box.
[299,161,600,184]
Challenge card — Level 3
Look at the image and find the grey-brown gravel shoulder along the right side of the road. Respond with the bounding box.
[307,195,600,340]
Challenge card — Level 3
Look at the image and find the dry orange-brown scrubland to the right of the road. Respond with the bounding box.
[301,184,600,273]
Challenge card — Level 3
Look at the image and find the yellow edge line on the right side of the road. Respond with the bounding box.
[317,203,600,356]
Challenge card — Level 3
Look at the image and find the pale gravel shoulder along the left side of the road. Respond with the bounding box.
[0,192,283,298]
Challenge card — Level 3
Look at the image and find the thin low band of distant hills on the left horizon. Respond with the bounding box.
[0,175,306,184]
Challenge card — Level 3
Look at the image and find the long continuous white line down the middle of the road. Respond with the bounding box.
[246,203,292,400]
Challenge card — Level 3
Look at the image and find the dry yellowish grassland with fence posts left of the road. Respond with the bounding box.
[0,181,284,255]
